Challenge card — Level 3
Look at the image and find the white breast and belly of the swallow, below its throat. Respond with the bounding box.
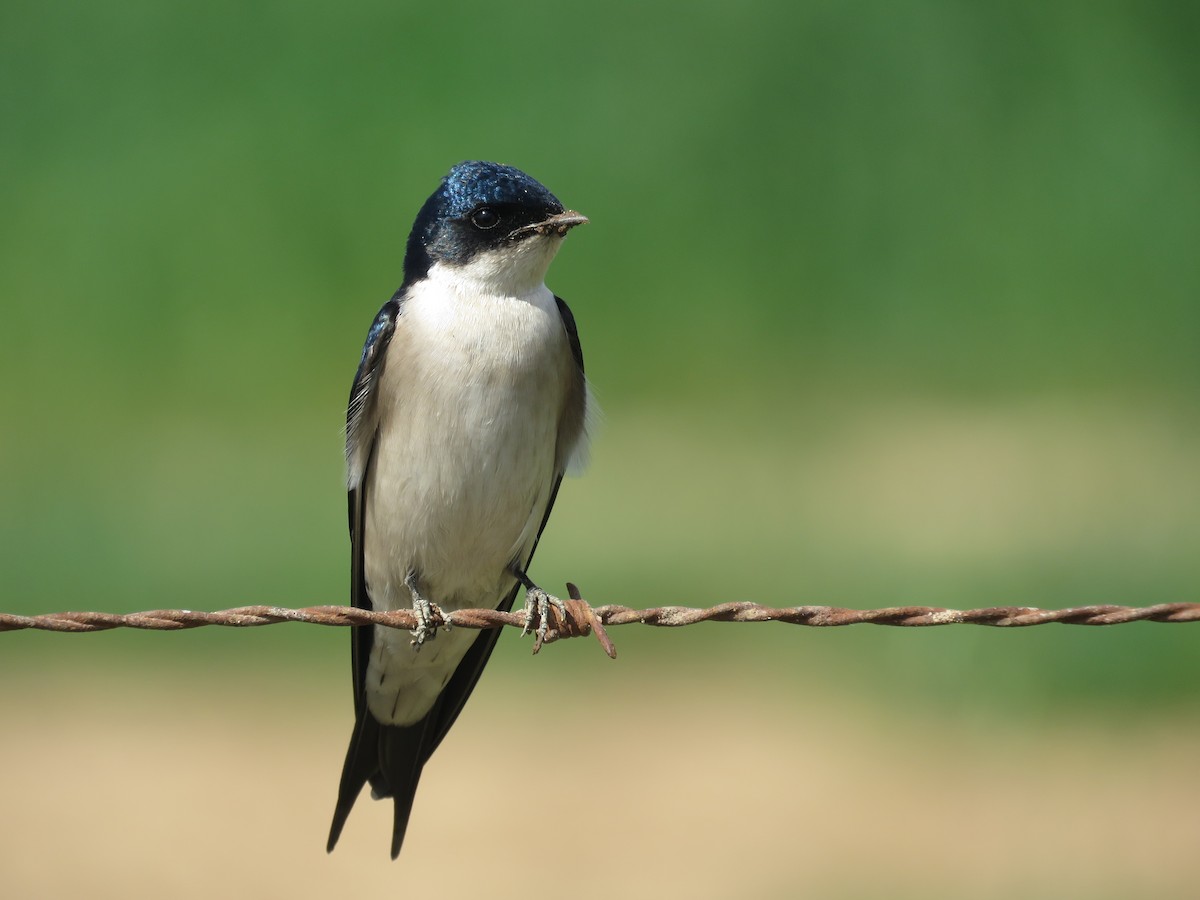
[364,271,572,725]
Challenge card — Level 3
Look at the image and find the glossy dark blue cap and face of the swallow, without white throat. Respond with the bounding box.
[404,161,587,284]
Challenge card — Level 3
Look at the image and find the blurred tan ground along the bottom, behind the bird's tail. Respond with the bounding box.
[0,671,1200,898]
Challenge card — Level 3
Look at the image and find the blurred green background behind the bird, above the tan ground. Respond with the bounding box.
[0,0,1200,897]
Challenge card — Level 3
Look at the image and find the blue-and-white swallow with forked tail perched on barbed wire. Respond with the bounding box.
[326,161,594,859]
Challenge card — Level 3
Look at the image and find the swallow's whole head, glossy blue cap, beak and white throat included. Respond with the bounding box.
[404,162,588,288]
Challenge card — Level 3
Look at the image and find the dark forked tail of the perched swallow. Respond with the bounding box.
[325,708,432,859]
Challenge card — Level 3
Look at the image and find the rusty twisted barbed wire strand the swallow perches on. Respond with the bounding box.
[0,583,1200,656]
